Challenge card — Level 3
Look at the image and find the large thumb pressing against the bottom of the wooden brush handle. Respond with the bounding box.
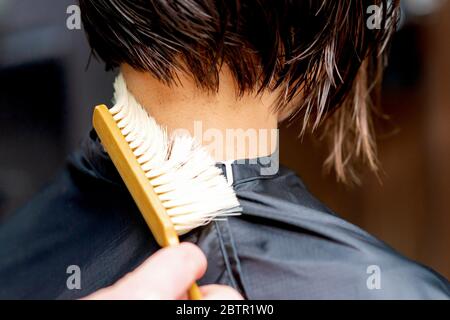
[84,243,207,300]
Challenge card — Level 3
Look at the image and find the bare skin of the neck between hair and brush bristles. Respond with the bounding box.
[121,65,278,161]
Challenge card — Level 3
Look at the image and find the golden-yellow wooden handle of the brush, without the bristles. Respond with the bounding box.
[93,105,202,300]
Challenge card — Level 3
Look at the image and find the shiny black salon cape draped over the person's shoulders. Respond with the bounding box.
[0,133,450,299]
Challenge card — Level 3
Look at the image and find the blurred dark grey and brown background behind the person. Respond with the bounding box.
[0,0,450,278]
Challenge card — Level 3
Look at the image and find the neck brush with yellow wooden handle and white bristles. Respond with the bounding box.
[93,75,241,298]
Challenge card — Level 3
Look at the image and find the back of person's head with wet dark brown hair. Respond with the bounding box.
[79,0,398,181]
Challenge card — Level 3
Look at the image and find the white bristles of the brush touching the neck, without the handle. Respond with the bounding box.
[110,74,241,235]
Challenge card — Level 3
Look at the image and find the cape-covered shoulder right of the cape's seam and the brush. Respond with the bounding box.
[229,166,450,299]
